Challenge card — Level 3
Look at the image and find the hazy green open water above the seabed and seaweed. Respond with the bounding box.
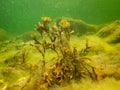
[0,0,120,33]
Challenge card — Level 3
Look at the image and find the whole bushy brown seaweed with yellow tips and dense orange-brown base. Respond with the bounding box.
[22,17,98,90]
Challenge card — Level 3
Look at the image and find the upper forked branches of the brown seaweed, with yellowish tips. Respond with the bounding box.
[33,17,73,59]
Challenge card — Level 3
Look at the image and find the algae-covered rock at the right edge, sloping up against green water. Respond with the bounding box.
[97,20,120,43]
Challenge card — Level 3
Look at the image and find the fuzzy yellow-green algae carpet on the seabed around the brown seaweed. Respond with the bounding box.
[0,17,120,90]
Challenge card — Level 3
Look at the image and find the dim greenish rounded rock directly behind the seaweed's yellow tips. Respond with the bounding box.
[56,18,97,36]
